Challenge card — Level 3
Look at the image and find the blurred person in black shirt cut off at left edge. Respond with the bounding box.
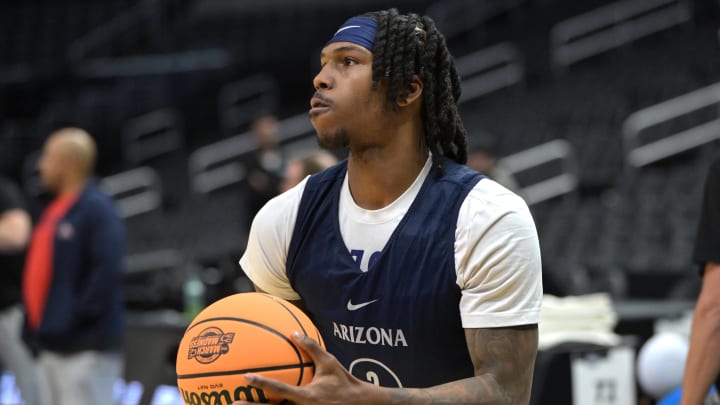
[0,176,40,405]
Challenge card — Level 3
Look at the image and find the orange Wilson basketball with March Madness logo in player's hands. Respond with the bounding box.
[176,293,325,405]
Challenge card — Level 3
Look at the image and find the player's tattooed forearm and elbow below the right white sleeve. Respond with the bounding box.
[374,325,537,405]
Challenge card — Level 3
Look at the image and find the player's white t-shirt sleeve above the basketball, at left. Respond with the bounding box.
[240,177,308,301]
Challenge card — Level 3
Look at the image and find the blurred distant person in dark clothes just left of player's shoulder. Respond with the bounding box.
[245,114,284,224]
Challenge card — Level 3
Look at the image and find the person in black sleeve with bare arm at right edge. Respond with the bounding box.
[681,158,720,405]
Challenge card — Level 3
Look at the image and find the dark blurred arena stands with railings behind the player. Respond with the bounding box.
[0,0,720,405]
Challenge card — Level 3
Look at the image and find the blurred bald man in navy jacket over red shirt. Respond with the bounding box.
[23,128,125,405]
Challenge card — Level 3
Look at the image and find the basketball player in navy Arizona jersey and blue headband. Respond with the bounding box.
[238,10,542,404]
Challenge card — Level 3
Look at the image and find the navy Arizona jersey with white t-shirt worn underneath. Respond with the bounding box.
[240,155,542,387]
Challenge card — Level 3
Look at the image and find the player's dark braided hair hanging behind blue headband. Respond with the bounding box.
[364,9,467,169]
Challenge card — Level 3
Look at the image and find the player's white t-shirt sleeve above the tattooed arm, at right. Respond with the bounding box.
[455,179,542,328]
